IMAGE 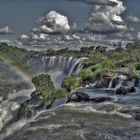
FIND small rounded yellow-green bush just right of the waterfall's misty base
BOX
[62,76,80,92]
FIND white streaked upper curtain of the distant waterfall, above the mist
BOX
[40,56,86,76]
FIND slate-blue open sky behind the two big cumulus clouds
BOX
[0,0,140,38]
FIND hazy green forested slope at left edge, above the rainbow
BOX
[0,43,38,77]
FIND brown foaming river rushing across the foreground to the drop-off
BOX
[0,88,140,140]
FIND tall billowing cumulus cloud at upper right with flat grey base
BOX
[88,0,127,32]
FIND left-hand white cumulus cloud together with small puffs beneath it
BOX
[19,11,74,44]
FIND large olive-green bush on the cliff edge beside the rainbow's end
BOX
[30,74,68,109]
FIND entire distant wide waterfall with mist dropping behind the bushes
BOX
[29,56,86,88]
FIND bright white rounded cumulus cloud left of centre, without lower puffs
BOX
[37,11,71,34]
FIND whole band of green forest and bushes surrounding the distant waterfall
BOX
[0,43,140,101]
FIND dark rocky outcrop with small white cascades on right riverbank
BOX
[90,68,136,95]
